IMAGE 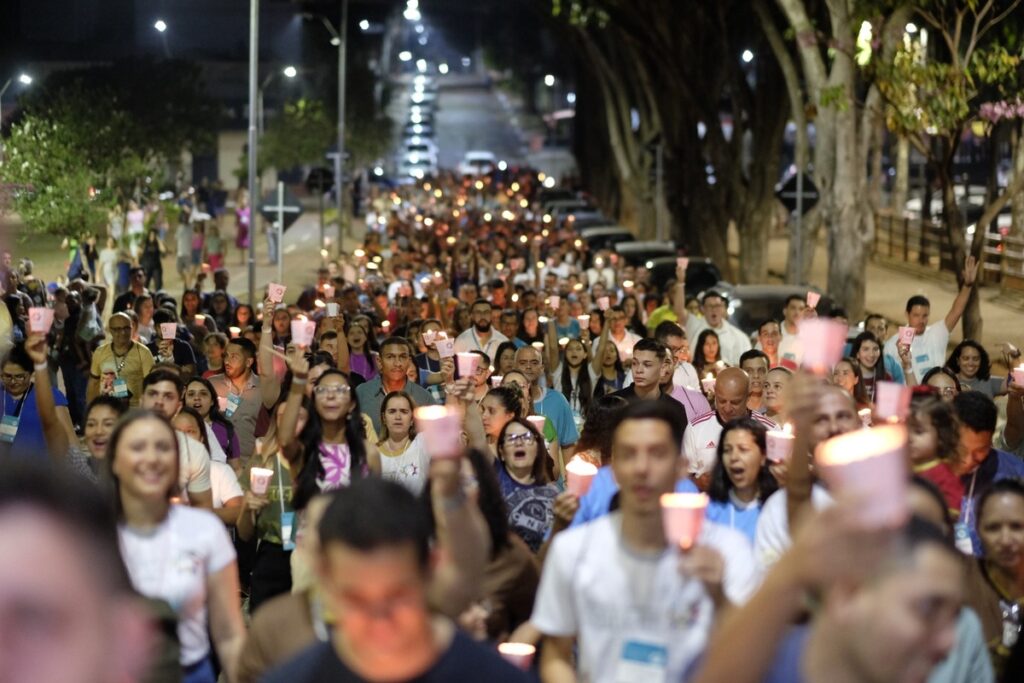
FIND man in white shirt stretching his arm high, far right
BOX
[885,256,978,384]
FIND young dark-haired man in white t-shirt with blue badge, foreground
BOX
[530,401,756,683]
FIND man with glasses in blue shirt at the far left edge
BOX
[0,337,75,459]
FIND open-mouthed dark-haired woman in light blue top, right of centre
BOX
[707,418,778,544]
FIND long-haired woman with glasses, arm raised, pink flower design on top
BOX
[280,348,380,510]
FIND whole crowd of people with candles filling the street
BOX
[0,166,1024,683]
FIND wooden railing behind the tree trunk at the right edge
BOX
[872,212,1024,292]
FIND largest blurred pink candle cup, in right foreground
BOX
[814,425,908,526]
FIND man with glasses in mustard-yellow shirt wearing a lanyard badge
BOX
[85,313,154,408]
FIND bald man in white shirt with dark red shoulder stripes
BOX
[683,368,778,490]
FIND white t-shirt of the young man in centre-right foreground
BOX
[530,513,714,683]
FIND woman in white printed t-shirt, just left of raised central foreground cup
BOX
[377,391,430,496]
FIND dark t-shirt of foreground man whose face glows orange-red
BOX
[262,631,536,683]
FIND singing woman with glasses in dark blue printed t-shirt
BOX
[497,418,567,553]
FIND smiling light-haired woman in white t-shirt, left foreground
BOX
[106,410,245,683]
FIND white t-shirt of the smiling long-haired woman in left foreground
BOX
[118,505,234,667]
